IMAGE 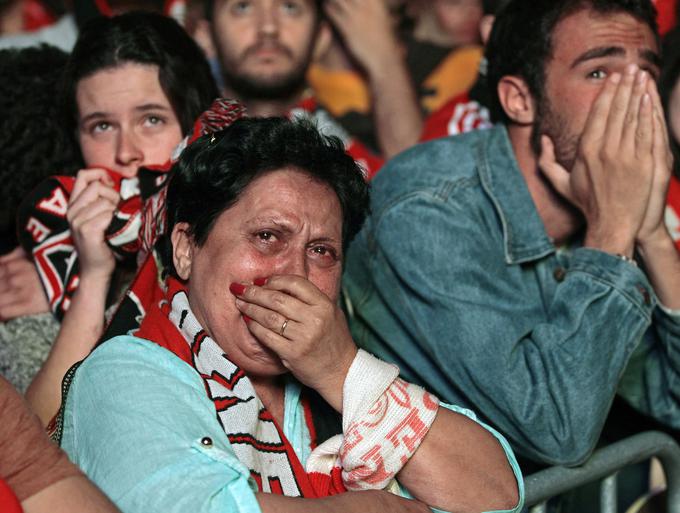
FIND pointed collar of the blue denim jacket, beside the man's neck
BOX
[476,125,555,264]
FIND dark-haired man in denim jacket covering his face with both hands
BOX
[345,0,680,464]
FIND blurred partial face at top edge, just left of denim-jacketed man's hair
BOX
[433,0,484,45]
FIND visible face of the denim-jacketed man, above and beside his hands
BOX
[533,9,659,169]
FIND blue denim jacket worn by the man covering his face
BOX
[344,126,680,464]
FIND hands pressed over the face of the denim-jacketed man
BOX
[539,65,670,256]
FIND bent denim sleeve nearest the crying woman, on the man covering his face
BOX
[345,169,678,465]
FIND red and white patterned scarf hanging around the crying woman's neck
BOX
[137,278,345,498]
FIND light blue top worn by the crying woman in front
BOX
[62,336,524,513]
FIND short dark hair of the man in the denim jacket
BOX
[486,0,658,123]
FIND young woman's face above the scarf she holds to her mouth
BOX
[76,63,182,178]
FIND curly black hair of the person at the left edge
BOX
[0,45,82,249]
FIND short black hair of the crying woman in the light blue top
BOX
[163,118,369,270]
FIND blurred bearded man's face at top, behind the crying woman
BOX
[212,0,318,99]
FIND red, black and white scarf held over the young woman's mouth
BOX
[17,99,246,321]
